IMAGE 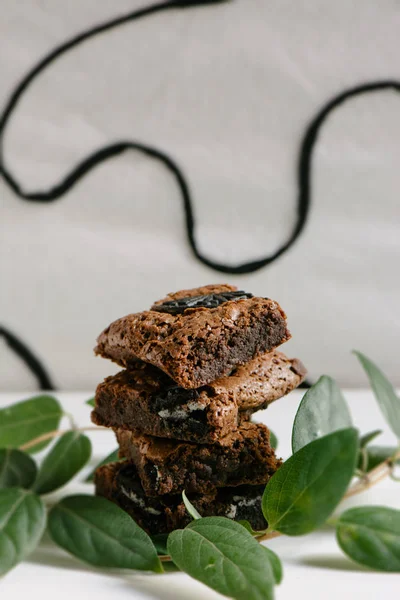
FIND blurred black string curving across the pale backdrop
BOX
[0,0,400,389]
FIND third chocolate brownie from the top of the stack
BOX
[116,423,281,496]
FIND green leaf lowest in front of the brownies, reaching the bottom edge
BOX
[167,517,275,600]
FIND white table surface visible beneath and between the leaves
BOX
[0,390,400,600]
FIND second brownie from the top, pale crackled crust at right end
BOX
[92,352,305,443]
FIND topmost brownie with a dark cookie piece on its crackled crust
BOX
[95,285,290,389]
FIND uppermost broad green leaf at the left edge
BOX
[0,396,63,454]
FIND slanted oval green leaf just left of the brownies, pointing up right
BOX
[34,431,92,494]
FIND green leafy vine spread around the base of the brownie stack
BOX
[0,353,400,600]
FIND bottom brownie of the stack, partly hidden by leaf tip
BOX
[95,463,267,535]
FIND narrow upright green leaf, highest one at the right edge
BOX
[354,350,400,440]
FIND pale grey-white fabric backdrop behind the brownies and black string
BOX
[0,0,400,389]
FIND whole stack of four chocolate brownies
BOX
[92,285,305,534]
